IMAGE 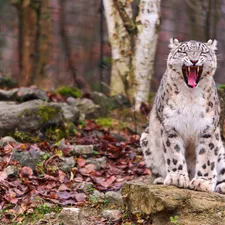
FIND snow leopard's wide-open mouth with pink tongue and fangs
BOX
[182,65,203,88]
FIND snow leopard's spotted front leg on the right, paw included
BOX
[190,132,218,192]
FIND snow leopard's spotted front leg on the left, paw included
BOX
[163,129,189,188]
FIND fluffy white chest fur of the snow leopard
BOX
[163,89,213,138]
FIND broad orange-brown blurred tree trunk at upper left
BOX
[10,0,51,86]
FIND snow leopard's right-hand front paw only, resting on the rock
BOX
[189,177,216,192]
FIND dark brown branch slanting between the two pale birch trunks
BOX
[113,0,137,36]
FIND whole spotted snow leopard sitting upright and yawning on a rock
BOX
[140,39,225,193]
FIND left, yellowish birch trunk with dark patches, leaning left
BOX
[103,0,132,95]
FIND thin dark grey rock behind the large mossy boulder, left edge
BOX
[0,87,48,102]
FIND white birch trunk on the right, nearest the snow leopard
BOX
[132,0,160,111]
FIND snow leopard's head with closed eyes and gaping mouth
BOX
[167,38,217,88]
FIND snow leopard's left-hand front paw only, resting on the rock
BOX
[164,172,189,188]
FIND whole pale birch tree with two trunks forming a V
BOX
[103,0,160,111]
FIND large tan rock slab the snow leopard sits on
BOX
[122,181,225,225]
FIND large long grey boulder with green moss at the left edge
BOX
[0,100,63,136]
